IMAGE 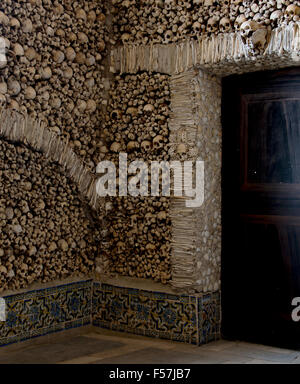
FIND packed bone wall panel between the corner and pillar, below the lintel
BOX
[101,72,171,283]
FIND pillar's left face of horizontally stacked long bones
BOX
[169,71,197,290]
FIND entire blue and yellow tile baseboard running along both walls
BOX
[0,279,220,346]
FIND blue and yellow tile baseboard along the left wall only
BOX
[0,279,93,346]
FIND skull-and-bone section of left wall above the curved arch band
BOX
[0,0,112,167]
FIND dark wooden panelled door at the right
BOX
[222,68,300,348]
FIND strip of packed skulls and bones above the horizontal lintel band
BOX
[112,0,300,44]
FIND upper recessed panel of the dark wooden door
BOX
[245,100,300,184]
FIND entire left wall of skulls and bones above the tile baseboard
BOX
[0,0,114,291]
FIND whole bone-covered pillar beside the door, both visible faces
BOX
[169,69,221,292]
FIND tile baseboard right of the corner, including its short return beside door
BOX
[92,282,221,345]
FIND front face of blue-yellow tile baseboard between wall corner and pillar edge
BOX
[93,284,197,343]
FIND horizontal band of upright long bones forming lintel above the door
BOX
[111,22,300,76]
